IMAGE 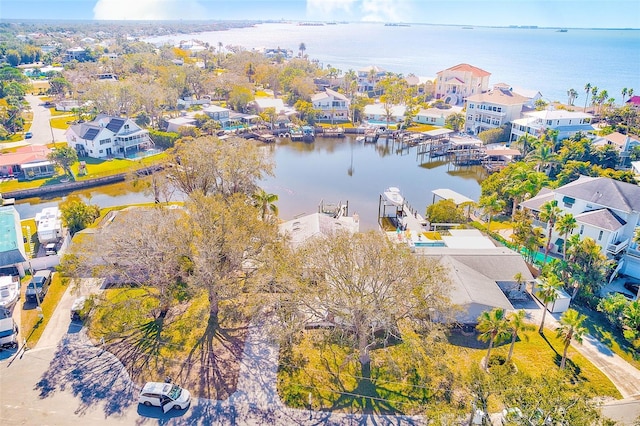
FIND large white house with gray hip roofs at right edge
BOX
[520,176,640,279]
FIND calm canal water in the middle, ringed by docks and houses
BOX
[16,136,485,230]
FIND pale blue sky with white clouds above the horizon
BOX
[0,0,640,28]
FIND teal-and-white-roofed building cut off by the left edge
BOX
[0,206,26,276]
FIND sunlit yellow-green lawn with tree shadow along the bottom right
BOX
[278,322,620,414]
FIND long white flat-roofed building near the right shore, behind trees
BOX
[509,109,594,142]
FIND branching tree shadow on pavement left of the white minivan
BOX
[35,332,135,416]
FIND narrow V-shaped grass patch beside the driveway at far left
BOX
[20,273,68,348]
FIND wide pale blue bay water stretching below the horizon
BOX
[146,23,640,106]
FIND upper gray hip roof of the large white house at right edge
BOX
[556,176,640,213]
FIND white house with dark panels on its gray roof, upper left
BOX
[65,114,154,158]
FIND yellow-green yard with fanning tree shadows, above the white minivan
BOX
[88,288,247,400]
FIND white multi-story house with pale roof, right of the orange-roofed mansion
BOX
[465,88,528,134]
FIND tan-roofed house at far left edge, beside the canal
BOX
[0,145,56,180]
